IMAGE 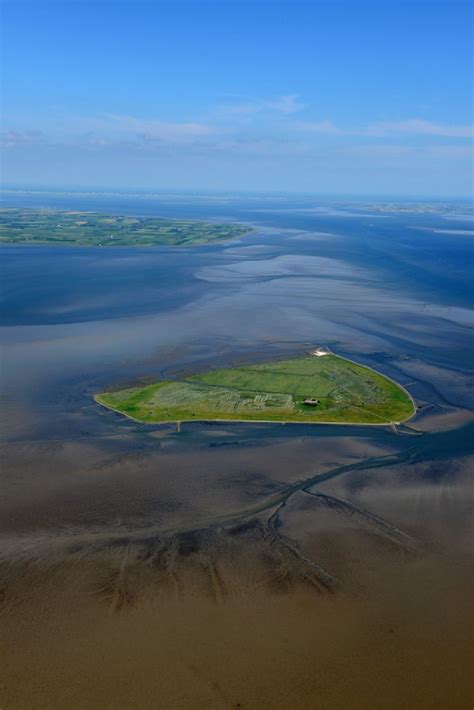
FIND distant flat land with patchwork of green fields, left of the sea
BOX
[0,208,252,247]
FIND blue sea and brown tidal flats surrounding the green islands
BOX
[0,194,474,710]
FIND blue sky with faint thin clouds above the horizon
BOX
[2,0,473,197]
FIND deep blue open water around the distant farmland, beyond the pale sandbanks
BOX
[0,194,474,324]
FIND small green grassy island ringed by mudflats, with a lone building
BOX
[95,348,416,425]
